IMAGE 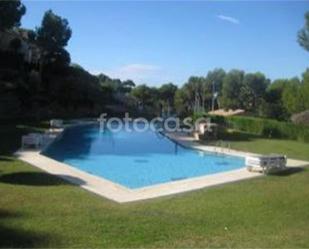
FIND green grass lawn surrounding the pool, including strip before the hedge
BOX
[0,125,309,248]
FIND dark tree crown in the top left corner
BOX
[0,0,26,31]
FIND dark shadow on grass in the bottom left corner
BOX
[0,209,57,248]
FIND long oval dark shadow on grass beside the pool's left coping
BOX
[0,172,85,186]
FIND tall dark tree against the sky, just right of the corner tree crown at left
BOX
[36,10,72,65]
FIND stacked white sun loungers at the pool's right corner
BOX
[246,155,287,174]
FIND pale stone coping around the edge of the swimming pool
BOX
[15,126,309,203]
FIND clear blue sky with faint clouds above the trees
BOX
[22,0,309,86]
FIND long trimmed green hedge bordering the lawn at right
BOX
[225,116,309,142]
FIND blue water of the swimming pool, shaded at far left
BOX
[43,125,244,189]
